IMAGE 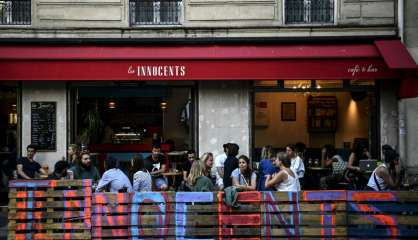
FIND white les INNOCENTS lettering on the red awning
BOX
[128,65,186,77]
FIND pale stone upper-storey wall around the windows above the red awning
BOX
[0,0,397,39]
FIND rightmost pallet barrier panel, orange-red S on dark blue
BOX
[347,192,418,239]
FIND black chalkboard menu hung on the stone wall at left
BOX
[31,102,57,151]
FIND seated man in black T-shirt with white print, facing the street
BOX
[144,145,168,191]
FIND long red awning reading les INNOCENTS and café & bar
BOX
[0,43,412,80]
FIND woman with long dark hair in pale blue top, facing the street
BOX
[231,155,257,191]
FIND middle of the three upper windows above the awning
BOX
[129,0,183,25]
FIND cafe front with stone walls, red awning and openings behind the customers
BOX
[0,0,418,180]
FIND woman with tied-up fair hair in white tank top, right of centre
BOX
[265,152,300,192]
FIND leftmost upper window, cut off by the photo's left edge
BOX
[0,0,31,25]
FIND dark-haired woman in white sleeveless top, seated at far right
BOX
[365,146,401,191]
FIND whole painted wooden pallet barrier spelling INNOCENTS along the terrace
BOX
[9,180,418,239]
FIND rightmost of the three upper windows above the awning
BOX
[285,0,334,24]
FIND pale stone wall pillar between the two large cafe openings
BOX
[198,81,251,156]
